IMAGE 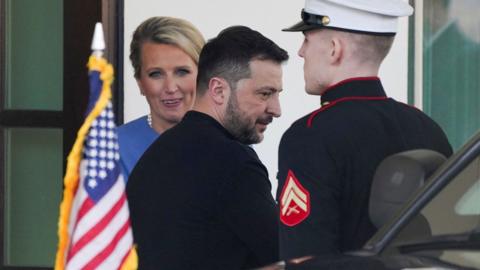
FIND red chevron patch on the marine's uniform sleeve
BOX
[280,170,310,227]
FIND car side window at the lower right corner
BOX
[387,157,480,268]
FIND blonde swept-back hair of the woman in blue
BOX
[130,17,205,79]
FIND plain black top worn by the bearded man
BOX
[127,111,278,270]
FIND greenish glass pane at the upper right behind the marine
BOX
[422,0,480,149]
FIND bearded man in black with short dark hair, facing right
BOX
[127,26,288,270]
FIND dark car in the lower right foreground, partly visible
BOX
[262,133,480,269]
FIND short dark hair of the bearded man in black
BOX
[197,26,288,96]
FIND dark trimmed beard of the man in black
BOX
[224,93,272,144]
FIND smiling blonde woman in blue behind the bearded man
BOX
[118,17,205,177]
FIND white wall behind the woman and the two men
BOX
[124,0,408,192]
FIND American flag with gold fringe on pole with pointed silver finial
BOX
[55,23,138,270]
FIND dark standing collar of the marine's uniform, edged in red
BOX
[321,77,387,106]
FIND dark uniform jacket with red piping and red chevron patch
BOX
[277,77,452,258]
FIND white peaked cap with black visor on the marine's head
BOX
[283,0,413,35]
